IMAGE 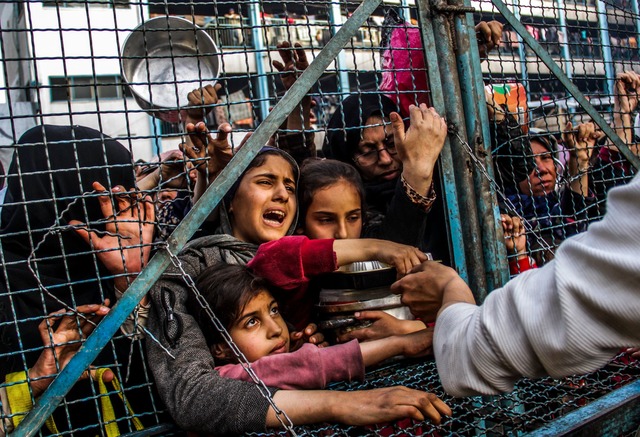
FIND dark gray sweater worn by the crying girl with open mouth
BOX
[146,235,276,435]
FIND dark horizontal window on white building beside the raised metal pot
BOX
[49,75,131,102]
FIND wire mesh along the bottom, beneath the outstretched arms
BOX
[247,356,640,436]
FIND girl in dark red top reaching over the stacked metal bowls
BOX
[248,159,426,341]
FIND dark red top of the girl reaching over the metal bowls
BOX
[247,235,338,330]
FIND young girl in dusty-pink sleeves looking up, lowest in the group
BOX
[189,264,449,420]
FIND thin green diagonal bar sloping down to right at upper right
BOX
[491,0,640,169]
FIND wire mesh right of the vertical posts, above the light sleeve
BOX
[475,1,638,265]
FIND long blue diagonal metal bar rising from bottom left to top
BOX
[12,0,382,436]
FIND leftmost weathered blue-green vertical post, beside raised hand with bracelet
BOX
[416,0,469,281]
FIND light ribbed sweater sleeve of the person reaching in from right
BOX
[434,176,640,396]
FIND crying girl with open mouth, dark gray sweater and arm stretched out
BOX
[147,147,448,435]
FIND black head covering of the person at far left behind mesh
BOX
[0,125,135,374]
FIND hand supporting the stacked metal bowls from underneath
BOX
[337,311,426,343]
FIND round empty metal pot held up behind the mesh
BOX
[121,16,220,123]
